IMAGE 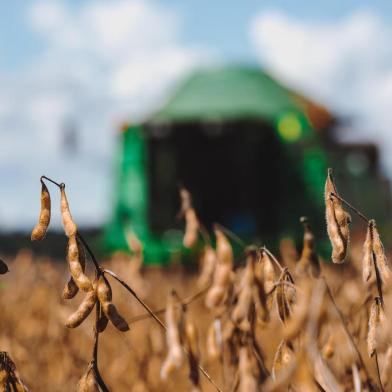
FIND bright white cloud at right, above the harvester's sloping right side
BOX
[250,11,392,175]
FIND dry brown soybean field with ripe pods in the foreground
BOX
[0,171,392,392]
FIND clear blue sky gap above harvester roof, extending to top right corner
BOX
[168,0,392,61]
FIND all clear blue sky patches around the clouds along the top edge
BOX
[0,0,392,69]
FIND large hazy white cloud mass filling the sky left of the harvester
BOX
[0,0,210,228]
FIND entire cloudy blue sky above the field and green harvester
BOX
[0,0,392,229]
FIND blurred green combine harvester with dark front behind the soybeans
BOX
[104,66,390,264]
